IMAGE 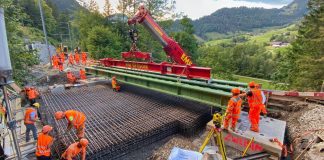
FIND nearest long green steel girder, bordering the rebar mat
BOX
[85,67,246,109]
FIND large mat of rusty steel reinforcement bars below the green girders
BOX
[42,86,210,159]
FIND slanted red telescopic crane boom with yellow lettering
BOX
[128,5,194,66]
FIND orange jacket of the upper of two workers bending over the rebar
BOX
[65,110,87,129]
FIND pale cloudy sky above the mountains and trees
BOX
[96,0,292,19]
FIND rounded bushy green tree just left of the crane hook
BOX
[87,26,122,59]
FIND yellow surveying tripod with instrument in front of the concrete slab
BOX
[199,113,227,160]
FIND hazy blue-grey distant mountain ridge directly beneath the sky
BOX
[193,0,307,38]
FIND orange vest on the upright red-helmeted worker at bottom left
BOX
[36,133,53,157]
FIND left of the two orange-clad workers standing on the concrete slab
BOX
[224,88,242,131]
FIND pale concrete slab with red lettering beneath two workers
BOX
[207,112,286,158]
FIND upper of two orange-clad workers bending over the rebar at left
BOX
[55,110,87,139]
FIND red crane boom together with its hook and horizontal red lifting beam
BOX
[100,5,211,79]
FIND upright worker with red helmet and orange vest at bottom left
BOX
[35,125,54,160]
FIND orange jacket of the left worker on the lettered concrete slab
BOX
[226,96,242,118]
